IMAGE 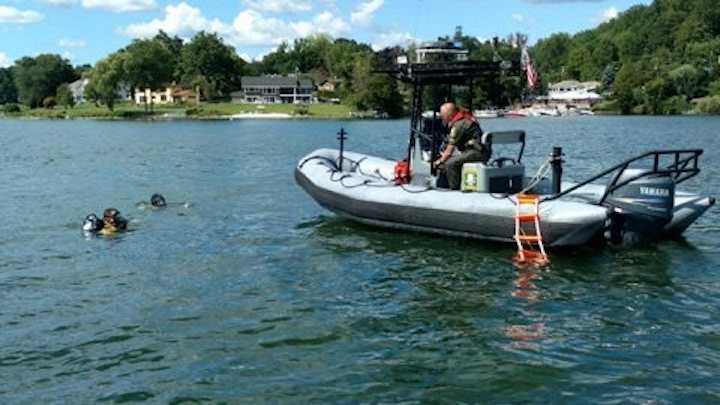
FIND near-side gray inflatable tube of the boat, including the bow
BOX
[295,149,608,247]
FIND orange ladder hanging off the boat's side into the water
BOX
[515,194,550,266]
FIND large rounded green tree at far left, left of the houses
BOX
[14,54,77,108]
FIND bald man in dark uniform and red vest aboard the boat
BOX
[434,103,492,190]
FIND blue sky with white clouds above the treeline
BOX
[0,0,651,67]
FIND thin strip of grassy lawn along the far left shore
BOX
[2,103,353,119]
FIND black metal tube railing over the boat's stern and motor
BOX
[543,149,703,205]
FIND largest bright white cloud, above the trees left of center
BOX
[121,2,350,47]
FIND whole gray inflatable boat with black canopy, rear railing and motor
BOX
[295,51,715,246]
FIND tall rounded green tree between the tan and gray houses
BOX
[179,32,245,99]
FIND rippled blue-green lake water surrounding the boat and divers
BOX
[0,117,720,404]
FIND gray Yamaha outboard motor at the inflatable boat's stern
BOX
[605,169,675,243]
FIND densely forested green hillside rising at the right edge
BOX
[532,0,720,114]
